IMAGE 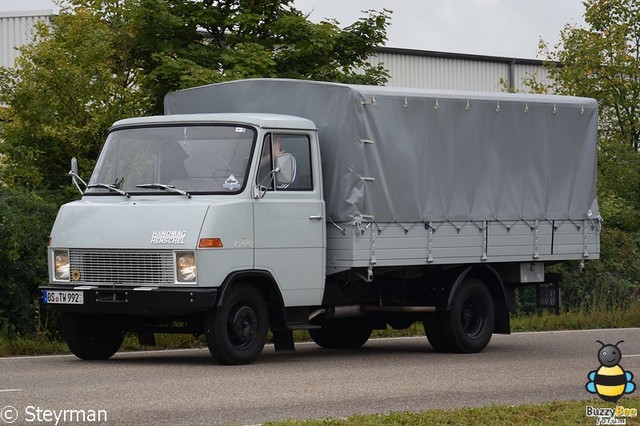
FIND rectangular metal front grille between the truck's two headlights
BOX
[69,249,175,285]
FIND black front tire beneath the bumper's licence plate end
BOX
[61,312,124,360]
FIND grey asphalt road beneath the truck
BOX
[0,328,640,426]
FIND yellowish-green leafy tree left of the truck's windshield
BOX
[0,7,149,188]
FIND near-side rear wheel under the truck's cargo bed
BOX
[442,278,495,353]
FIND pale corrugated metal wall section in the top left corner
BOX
[0,10,53,67]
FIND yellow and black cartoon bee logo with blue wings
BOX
[585,340,636,404]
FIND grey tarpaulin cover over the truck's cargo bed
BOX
[165,79,598,222]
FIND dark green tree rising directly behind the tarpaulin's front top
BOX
[120,0,389,112]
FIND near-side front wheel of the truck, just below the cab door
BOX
[204,283,269,365]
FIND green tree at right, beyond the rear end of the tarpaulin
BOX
[541,0,640,150]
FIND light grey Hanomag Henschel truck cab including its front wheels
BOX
[42,114,325,363]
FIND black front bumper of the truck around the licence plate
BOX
[40,285,218,316]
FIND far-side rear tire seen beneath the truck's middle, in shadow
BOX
[309,318,373,349]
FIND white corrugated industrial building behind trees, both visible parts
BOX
[0,10,549,92]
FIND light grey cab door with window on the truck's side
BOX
[254,133,326,306]
